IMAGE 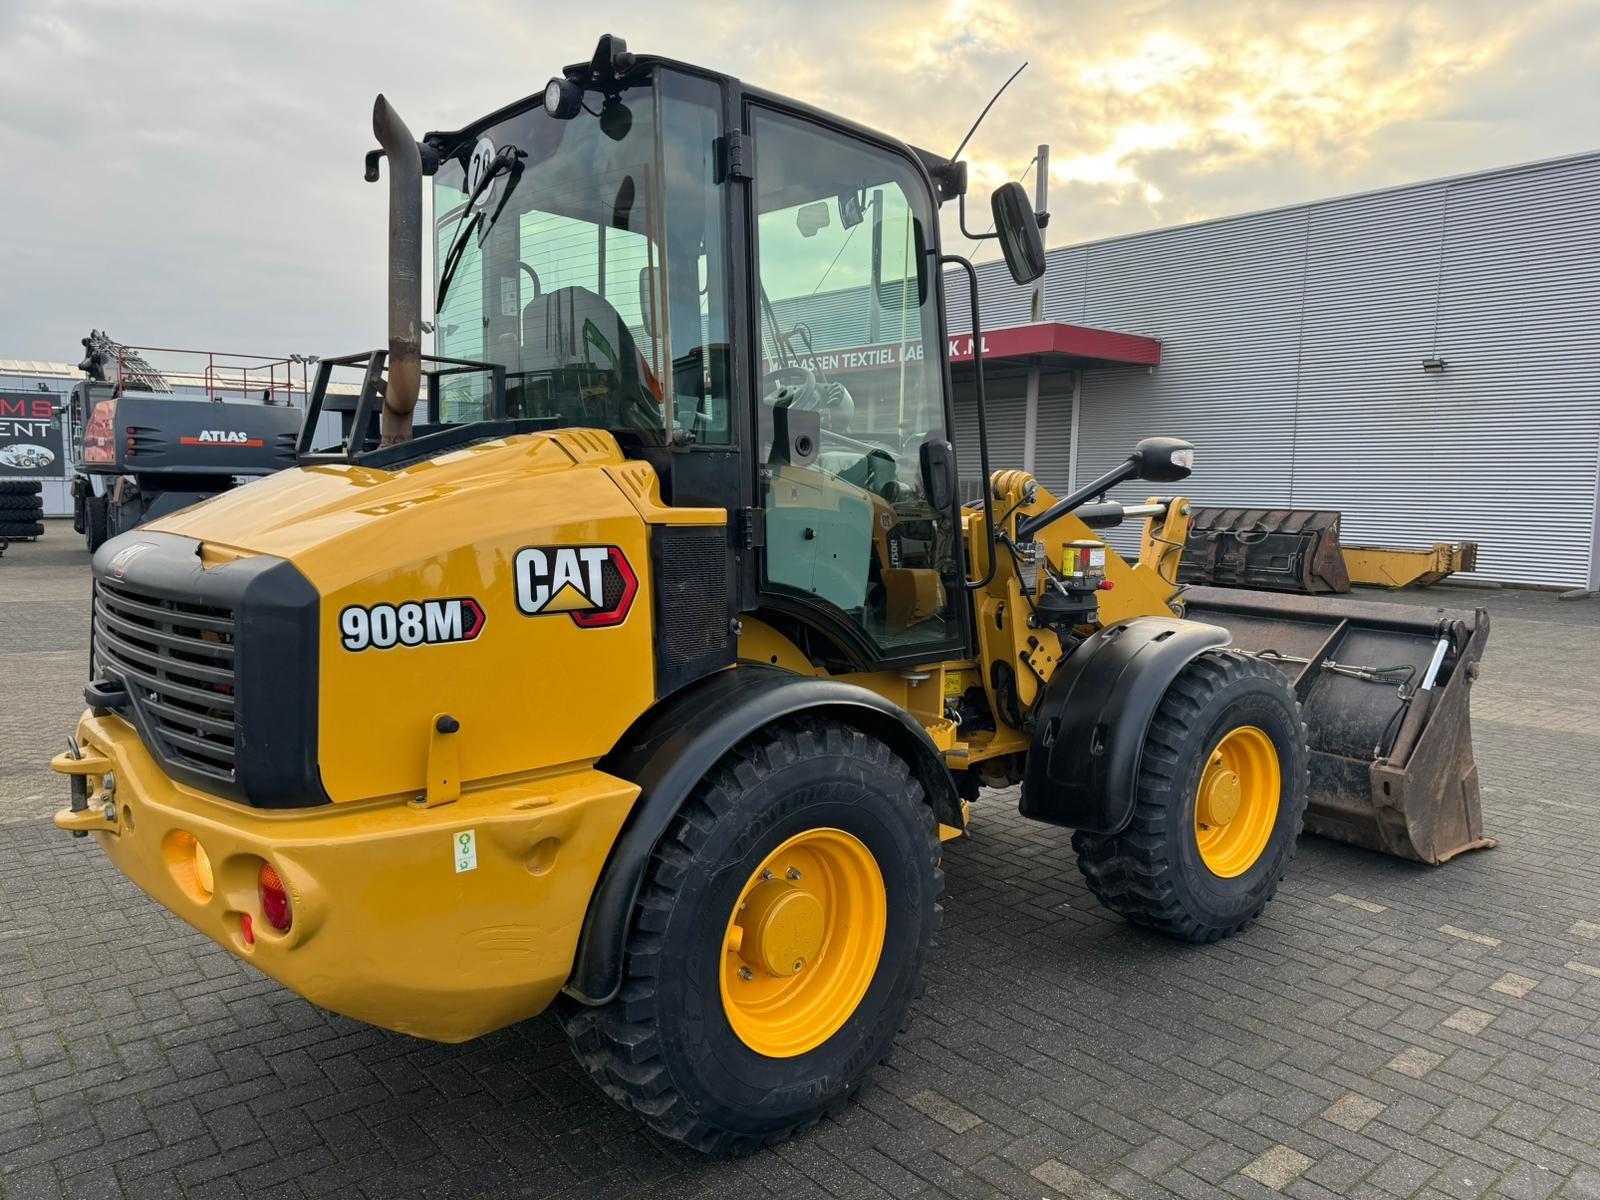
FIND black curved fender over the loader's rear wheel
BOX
[566,664,965,1005]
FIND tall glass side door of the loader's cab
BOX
[749,106,966,666]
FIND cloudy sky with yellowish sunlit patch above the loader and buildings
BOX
[0,0,1600,362]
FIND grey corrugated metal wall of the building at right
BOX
[946,154,1600,586]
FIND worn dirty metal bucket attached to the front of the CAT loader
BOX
[1182,587,1494,864]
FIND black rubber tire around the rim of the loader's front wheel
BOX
[1072,650,1310,942]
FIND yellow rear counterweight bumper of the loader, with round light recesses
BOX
[51,712,638,1042]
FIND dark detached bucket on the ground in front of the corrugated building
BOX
[1178,507,1350,594]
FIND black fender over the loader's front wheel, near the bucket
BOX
[1019,616,1230,834]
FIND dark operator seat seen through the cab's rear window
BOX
[518,286,661,429]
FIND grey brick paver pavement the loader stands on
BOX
[0,522,1600,1200]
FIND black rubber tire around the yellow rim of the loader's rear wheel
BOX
[558,718,942,1154]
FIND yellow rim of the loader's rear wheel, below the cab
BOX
[722,829,888,1058]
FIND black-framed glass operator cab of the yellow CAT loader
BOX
[344,37,1037,669]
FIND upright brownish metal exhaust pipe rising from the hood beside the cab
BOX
[368,94,422,446]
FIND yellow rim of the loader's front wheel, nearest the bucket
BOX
[1195,725,1283,878]
